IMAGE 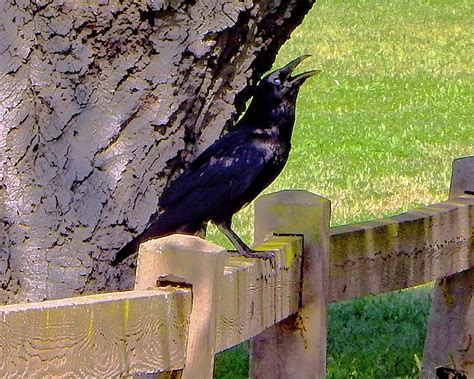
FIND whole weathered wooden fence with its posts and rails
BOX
[0,157,474,378]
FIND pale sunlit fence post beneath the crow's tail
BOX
[135,235,226,379]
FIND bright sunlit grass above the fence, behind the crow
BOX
[211,0,474,248]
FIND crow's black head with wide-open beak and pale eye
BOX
[243,55,320,127]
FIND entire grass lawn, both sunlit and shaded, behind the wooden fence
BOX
[210,0,474,378]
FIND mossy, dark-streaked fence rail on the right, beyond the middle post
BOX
[329,195,474,301]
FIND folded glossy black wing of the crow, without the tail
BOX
[160,130,272,207]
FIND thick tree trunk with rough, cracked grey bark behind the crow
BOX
[0,0,314,303]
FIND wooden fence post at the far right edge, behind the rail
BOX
[422,156,474,378]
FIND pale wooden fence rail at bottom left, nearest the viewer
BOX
[0,288,191,377]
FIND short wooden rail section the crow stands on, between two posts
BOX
[216,236,302,351]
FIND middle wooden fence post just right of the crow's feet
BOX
[250,191,330,379]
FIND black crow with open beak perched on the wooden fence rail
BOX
[113,55,320,265]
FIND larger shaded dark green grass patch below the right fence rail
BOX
[327,286,432,379]
